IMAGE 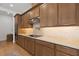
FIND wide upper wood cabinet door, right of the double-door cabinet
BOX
[59,3,75,25]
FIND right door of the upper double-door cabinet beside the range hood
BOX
[47,3,57,27]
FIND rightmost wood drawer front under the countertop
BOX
[56,45,78,55]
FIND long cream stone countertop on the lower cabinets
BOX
[19,34,79,49]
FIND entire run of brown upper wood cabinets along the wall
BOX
[15,3,79,28]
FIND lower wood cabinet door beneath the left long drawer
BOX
[35,43,52,56]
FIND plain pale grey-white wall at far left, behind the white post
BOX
[0,15,13,41]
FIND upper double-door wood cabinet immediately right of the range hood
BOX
[40,3,57,27]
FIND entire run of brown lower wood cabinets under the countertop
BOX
[16,35,79,56]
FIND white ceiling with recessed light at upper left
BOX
[0,3,32,14]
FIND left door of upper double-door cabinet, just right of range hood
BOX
[40,4,48,27]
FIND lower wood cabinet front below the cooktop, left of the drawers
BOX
[25,37,35,55]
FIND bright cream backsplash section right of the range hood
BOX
[41,26,79,39]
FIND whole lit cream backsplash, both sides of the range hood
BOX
[19,26,79,39]
